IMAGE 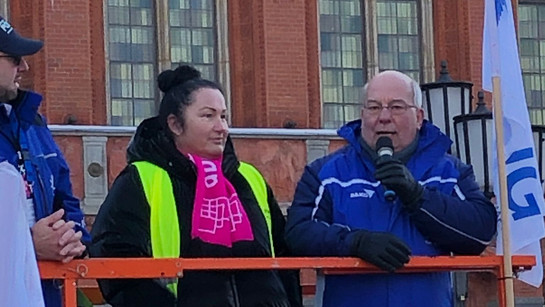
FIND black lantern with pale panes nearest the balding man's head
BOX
[420,60,473,155]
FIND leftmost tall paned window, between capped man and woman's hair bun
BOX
[108,0,157,126]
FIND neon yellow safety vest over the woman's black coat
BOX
[132,161,275,296]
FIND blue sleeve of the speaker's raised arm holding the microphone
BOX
[411,160,497,255]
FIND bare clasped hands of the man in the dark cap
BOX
[32,209,85,263]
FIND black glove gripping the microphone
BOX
[375,157,424,210]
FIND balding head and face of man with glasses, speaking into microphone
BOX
[361,72,424,152]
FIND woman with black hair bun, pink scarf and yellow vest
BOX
[90,66,302,307]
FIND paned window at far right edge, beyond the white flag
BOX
[518,1,545,125]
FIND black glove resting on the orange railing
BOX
[351,230,411,272]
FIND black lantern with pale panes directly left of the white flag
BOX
[454,91,495,198]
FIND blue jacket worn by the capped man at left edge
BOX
[0,91,90,307]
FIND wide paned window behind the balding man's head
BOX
[319,0,434,129]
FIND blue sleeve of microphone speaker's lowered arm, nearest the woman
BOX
[286,158,352,256]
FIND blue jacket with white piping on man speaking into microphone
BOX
[286,120,497,307]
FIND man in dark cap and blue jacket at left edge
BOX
[0,16,90,307]
